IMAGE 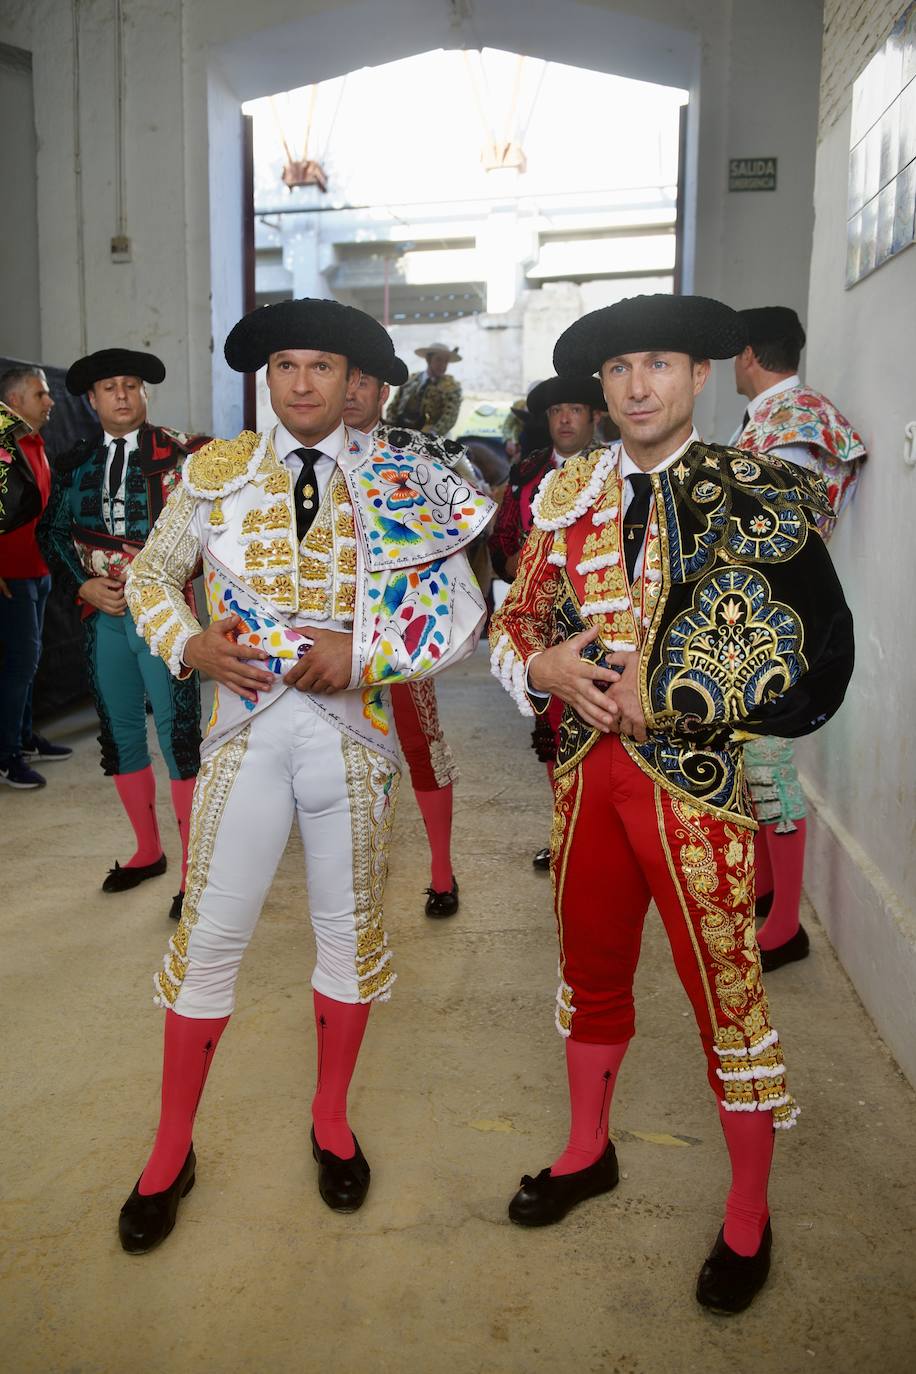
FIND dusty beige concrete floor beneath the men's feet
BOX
[0,651,916,1374]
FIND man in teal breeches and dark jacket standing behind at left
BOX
[40,348,209,921]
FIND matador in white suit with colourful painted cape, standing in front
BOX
[119,300,492,1253]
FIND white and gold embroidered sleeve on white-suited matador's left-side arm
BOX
[125,484,202,679]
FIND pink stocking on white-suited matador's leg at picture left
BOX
[140,1010,229,1197]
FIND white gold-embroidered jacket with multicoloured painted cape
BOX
[126,431,492,761]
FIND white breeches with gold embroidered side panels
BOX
[155,690,400,1018]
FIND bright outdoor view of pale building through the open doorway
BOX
[246,49,687,397]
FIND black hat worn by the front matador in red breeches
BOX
[553,295,747,376]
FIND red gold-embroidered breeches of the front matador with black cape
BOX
[551,735,797,1125]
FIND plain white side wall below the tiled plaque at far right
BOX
[799,85,916,1083]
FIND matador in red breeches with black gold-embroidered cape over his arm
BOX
[490,295,853,1312]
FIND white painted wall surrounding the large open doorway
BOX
[0,0,820,436]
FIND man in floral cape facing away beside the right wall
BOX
[733,305,867,971]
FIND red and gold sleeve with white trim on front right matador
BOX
[490,529,560,716]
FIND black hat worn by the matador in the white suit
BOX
[224,297,394,376]
